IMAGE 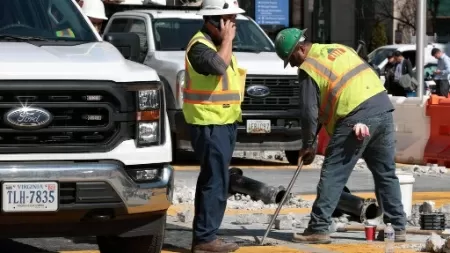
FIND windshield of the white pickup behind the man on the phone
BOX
[153,18,275,53]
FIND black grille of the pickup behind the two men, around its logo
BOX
[242,76,299,110]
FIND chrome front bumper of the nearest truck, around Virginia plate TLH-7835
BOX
[0,161,174,214]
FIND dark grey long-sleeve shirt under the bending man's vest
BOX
[298,70,394,148]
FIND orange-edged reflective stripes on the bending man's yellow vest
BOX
[303,58,370,124]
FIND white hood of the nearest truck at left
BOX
[0,42,159,82]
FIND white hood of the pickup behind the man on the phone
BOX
[155,51,297,75]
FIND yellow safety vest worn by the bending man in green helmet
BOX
[300,44,385,135]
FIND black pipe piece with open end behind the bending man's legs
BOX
[332,187,382,223]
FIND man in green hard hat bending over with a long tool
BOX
[275,28,406,243]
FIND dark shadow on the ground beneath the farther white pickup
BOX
[172,151,289,166]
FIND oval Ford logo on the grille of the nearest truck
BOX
[4,107,53,130]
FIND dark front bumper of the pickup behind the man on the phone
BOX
[172,110,302,151]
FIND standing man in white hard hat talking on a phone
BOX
[183,0,245,253]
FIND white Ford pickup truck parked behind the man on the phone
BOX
[104,5,302,164]
